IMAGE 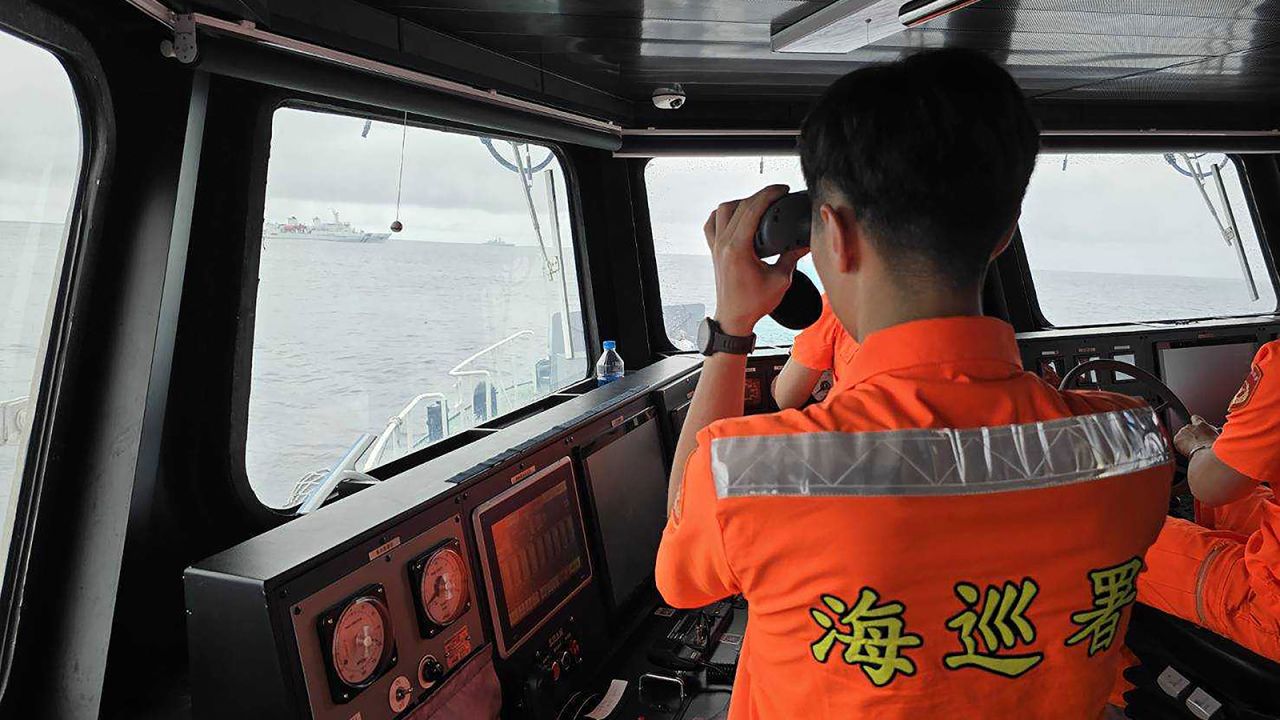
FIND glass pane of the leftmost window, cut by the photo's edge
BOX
[0,32,84,577]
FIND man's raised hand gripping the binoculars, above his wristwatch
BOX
[703,184,809,336]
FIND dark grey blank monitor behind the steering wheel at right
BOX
[1156,340,1257,429]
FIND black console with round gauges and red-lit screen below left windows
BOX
[184,357,700,720]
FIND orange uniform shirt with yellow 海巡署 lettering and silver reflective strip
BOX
[657,318,1172,720]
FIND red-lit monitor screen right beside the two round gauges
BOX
[475,457,591,657]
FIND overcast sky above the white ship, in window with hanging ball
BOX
[266,109,570,245]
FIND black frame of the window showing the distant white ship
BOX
[229,98,598,512]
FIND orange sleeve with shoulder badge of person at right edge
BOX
[1213,342,1280,483]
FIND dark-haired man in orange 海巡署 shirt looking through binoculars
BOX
[657,50,1172,720]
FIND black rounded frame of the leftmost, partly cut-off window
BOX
[0,0,115,706]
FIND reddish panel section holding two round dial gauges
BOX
[289,514,484,720]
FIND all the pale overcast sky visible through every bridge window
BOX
[0,21,1262,278]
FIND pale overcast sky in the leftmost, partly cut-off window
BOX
[0,32,81,223]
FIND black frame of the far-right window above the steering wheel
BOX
[1002,153,1280,331]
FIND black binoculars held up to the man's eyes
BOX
[754,190,822,331]
